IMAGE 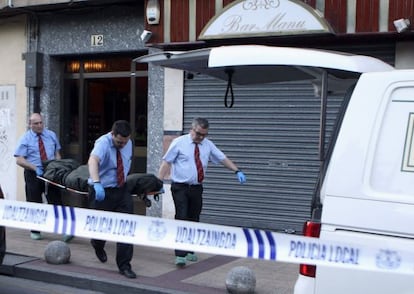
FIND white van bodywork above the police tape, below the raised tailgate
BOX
[321,71,414,234]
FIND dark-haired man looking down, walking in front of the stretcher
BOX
[88,120,136,279]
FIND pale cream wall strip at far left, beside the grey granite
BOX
[0,15,27,199]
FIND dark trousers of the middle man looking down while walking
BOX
[89,185,134,271]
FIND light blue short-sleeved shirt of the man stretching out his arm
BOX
[163,134,226,185]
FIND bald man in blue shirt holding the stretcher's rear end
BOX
[14,113,63,241]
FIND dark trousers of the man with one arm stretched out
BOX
[171,183,203,257]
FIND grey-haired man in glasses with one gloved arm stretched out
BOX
[158,118,246,266]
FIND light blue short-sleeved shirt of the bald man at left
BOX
[14,129,62,167]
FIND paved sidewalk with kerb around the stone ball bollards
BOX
[0,228,298,294]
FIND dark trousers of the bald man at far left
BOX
[24,169,63,233]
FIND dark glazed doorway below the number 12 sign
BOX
[61,55,148,173]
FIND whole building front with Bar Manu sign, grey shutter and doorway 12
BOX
[0,0,414,232]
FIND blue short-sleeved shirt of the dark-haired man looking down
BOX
[89,133,132,188]
